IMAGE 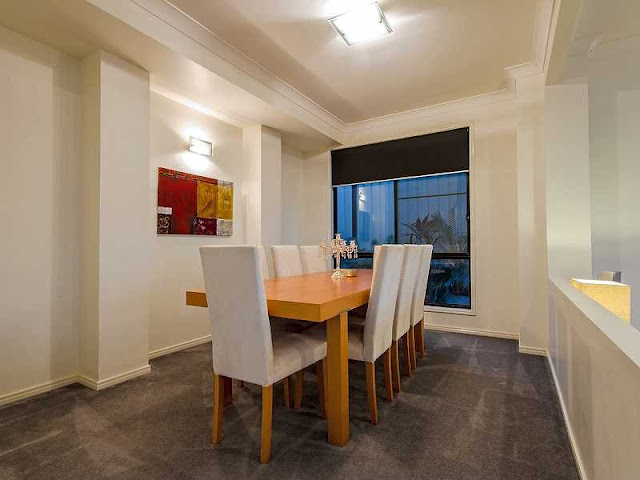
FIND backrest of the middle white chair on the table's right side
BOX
[393,245,424,340]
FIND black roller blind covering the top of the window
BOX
[331,127,469,185]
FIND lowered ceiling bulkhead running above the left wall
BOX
[0,0,336,152]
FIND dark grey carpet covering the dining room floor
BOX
[0,333,578,480]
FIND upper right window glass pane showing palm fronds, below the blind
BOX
[398,173,469,254]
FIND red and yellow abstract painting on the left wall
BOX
[157,168,233,237]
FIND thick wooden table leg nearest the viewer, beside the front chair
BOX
[326,312,349,446]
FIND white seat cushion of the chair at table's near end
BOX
[271,331,327,383]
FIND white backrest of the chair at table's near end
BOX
[200,246,273,386]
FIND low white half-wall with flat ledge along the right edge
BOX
[549,278,640,480]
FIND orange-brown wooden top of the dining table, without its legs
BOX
[187,270,373,322]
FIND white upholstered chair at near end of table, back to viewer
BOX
[200,246,327,463]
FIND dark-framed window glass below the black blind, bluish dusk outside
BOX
[334,171,471,309]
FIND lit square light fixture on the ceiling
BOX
[329,2,392,47]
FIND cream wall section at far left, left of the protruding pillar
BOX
[0,28,80,403]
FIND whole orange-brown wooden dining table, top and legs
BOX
[186,270,372,446]
